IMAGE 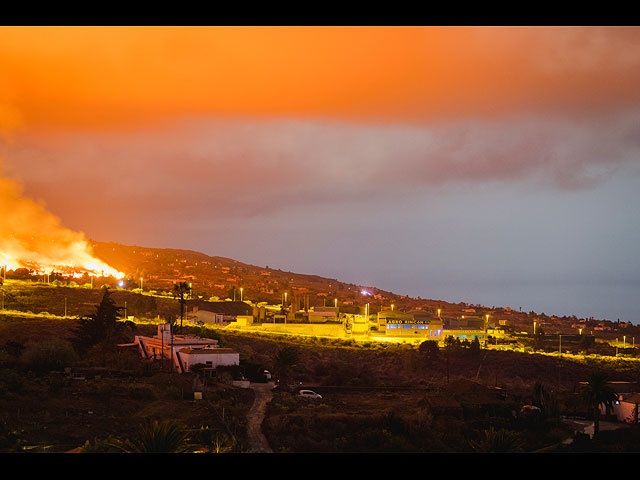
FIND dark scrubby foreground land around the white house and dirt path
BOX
[0,306,640,453]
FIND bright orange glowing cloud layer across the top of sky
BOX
[0,27,640,126]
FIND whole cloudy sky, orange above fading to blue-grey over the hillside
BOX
[0,27,640,323]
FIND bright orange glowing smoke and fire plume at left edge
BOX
[0,166,124,278]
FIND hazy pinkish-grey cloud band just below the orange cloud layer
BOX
[6,111,640,229]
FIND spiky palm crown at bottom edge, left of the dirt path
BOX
[111,420,193,453]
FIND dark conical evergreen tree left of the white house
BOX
[73,288,135,351]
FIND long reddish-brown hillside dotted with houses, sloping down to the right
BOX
[85,242,616,333]
